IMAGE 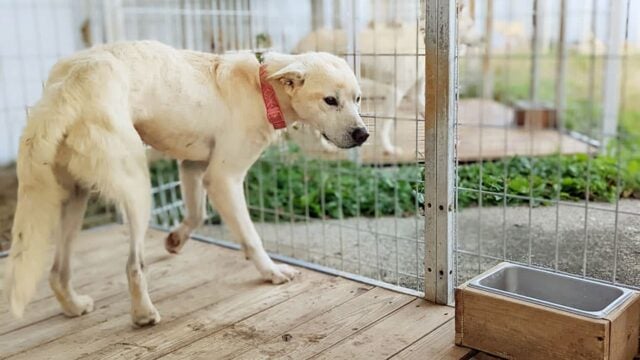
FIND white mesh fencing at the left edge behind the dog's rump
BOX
[0,0,117,233]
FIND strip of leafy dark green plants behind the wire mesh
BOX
[152,144,640,221]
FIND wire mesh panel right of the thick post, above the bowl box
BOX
[455,0,640,287]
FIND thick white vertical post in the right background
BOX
[594,0,626,146]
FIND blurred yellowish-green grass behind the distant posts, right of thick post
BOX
[460,52,640,138]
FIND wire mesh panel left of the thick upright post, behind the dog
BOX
[108,0,432,292]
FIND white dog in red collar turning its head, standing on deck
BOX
[5,41,369,326]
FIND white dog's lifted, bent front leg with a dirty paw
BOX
[164,160,207,254]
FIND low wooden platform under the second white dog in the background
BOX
[300,99,593,164]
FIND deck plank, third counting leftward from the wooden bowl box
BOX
[175,285,413,360]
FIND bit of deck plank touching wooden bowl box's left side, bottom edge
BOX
[392,320,472,360]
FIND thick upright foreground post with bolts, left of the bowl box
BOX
[424,0,457,304]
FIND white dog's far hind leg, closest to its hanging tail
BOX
[49,185,93,316]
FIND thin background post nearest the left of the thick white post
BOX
[555,0,567,130]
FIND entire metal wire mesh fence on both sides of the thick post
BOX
[0,0,640,294]
